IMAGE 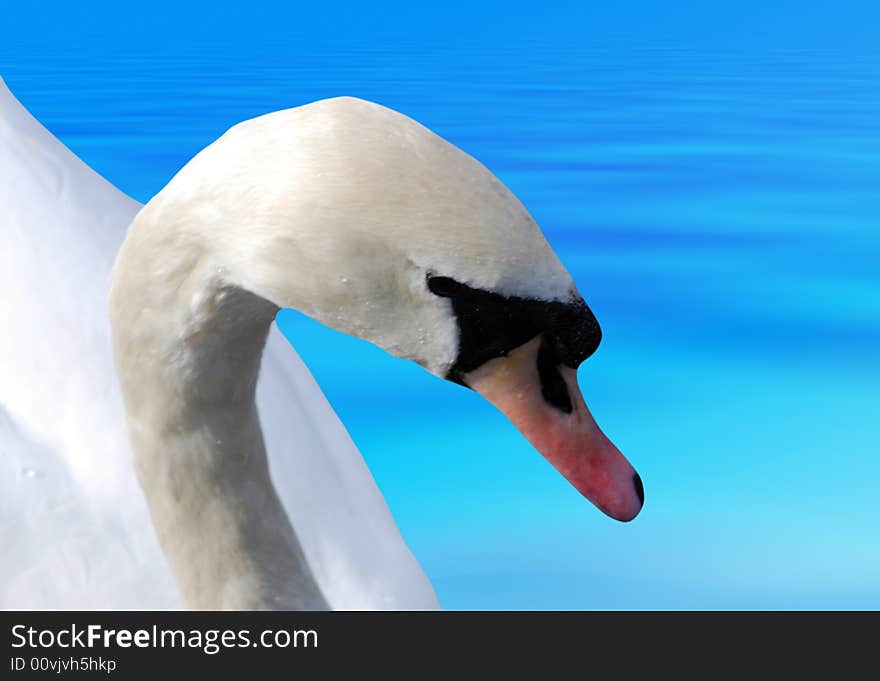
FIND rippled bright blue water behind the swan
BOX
[0,0,880,608]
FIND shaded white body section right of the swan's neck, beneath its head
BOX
[257,324,439,610]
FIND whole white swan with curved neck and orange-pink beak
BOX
[0,81,644,609]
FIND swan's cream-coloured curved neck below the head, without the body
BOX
[111,245,327,610]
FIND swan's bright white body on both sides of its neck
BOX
[0,80,437,609]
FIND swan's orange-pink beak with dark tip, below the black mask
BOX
[463,336,645,522]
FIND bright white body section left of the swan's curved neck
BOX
[0,80,179,609]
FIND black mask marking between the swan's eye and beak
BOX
[427,275,602,386]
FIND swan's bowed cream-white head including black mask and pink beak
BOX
[139,97,643,521]
